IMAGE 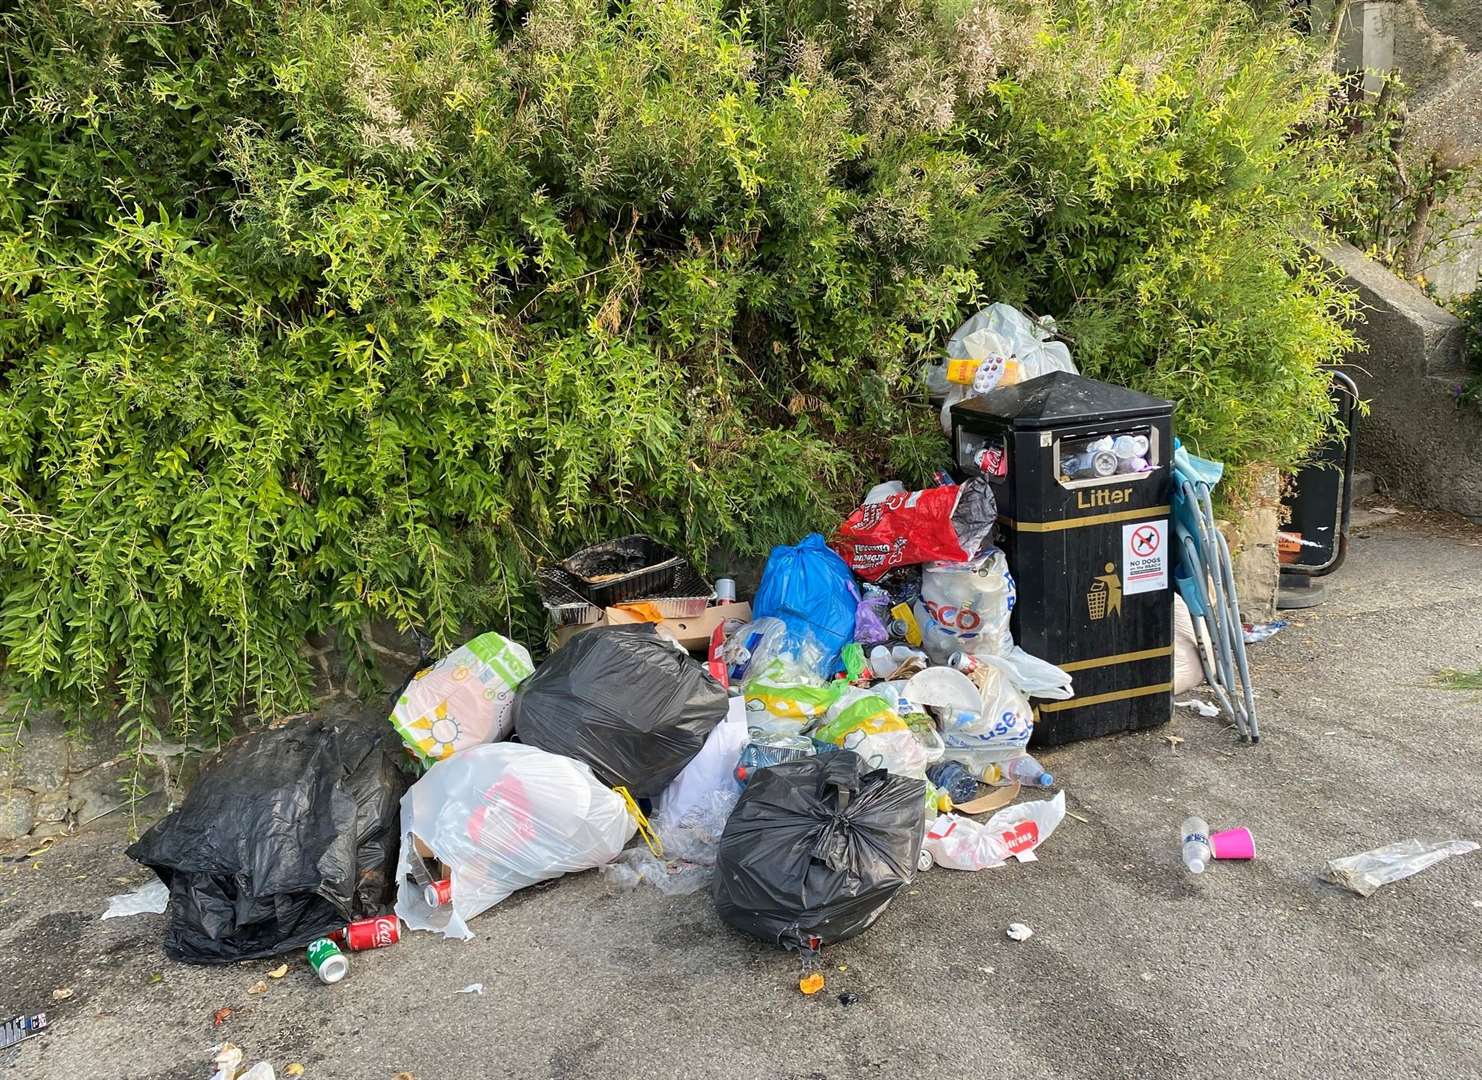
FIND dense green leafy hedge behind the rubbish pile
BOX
[0,0,1350,738]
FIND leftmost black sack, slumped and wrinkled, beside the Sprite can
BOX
[127,717,408,963]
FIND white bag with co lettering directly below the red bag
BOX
[916,548,1018,664]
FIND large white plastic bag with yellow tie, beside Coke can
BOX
[396,742,637,938]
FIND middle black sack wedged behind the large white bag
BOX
[514,624,726,799]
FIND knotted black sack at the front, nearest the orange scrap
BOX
[714,750,926,948]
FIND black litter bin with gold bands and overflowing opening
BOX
[951,372,1174,745]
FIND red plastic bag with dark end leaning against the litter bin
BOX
[831,477,999,581]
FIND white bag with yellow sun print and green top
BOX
[391,633,535,766]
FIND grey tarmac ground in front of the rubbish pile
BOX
[0,513,1482,1080]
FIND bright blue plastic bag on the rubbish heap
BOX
[751,532,860,679]
